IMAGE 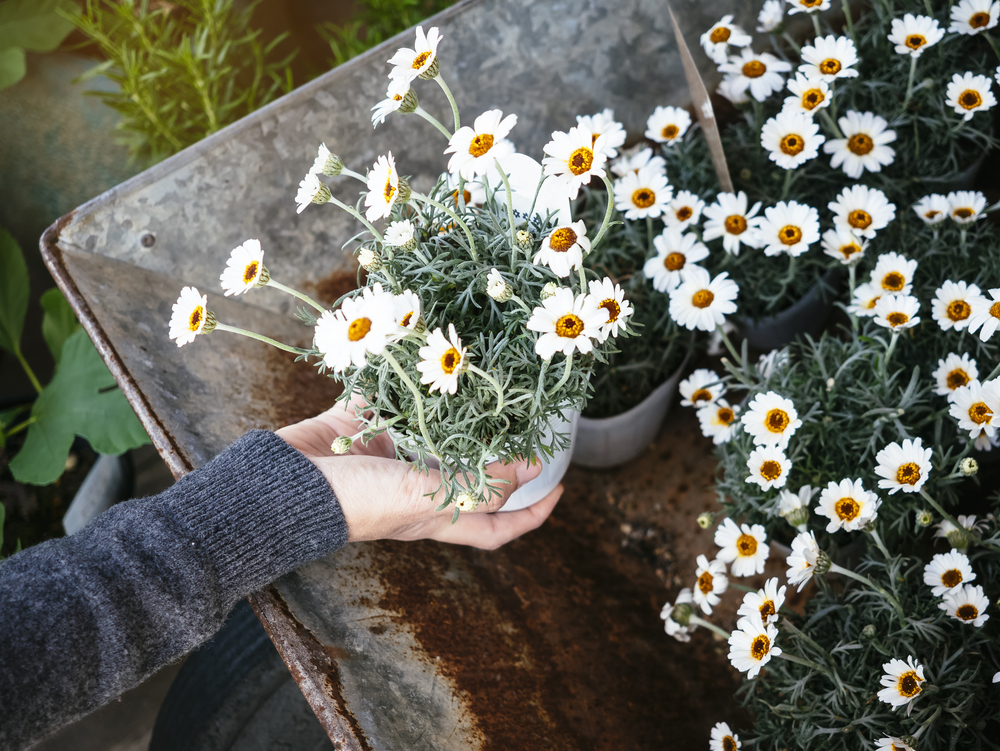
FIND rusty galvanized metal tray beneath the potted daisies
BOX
[42,0,753,751]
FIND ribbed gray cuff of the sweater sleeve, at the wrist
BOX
[164,430,347,599]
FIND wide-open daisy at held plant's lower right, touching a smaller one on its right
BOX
[527,287,608,360]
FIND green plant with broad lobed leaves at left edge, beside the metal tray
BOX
[0,229,149,485]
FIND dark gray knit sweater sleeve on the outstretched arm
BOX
[0,430,347,751]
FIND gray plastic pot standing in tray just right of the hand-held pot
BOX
[573,353,691,469]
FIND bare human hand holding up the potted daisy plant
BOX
[277,402,563,550]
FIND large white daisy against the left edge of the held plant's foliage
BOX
[314,296,397,373]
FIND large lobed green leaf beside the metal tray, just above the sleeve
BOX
[10,329,149,485]
